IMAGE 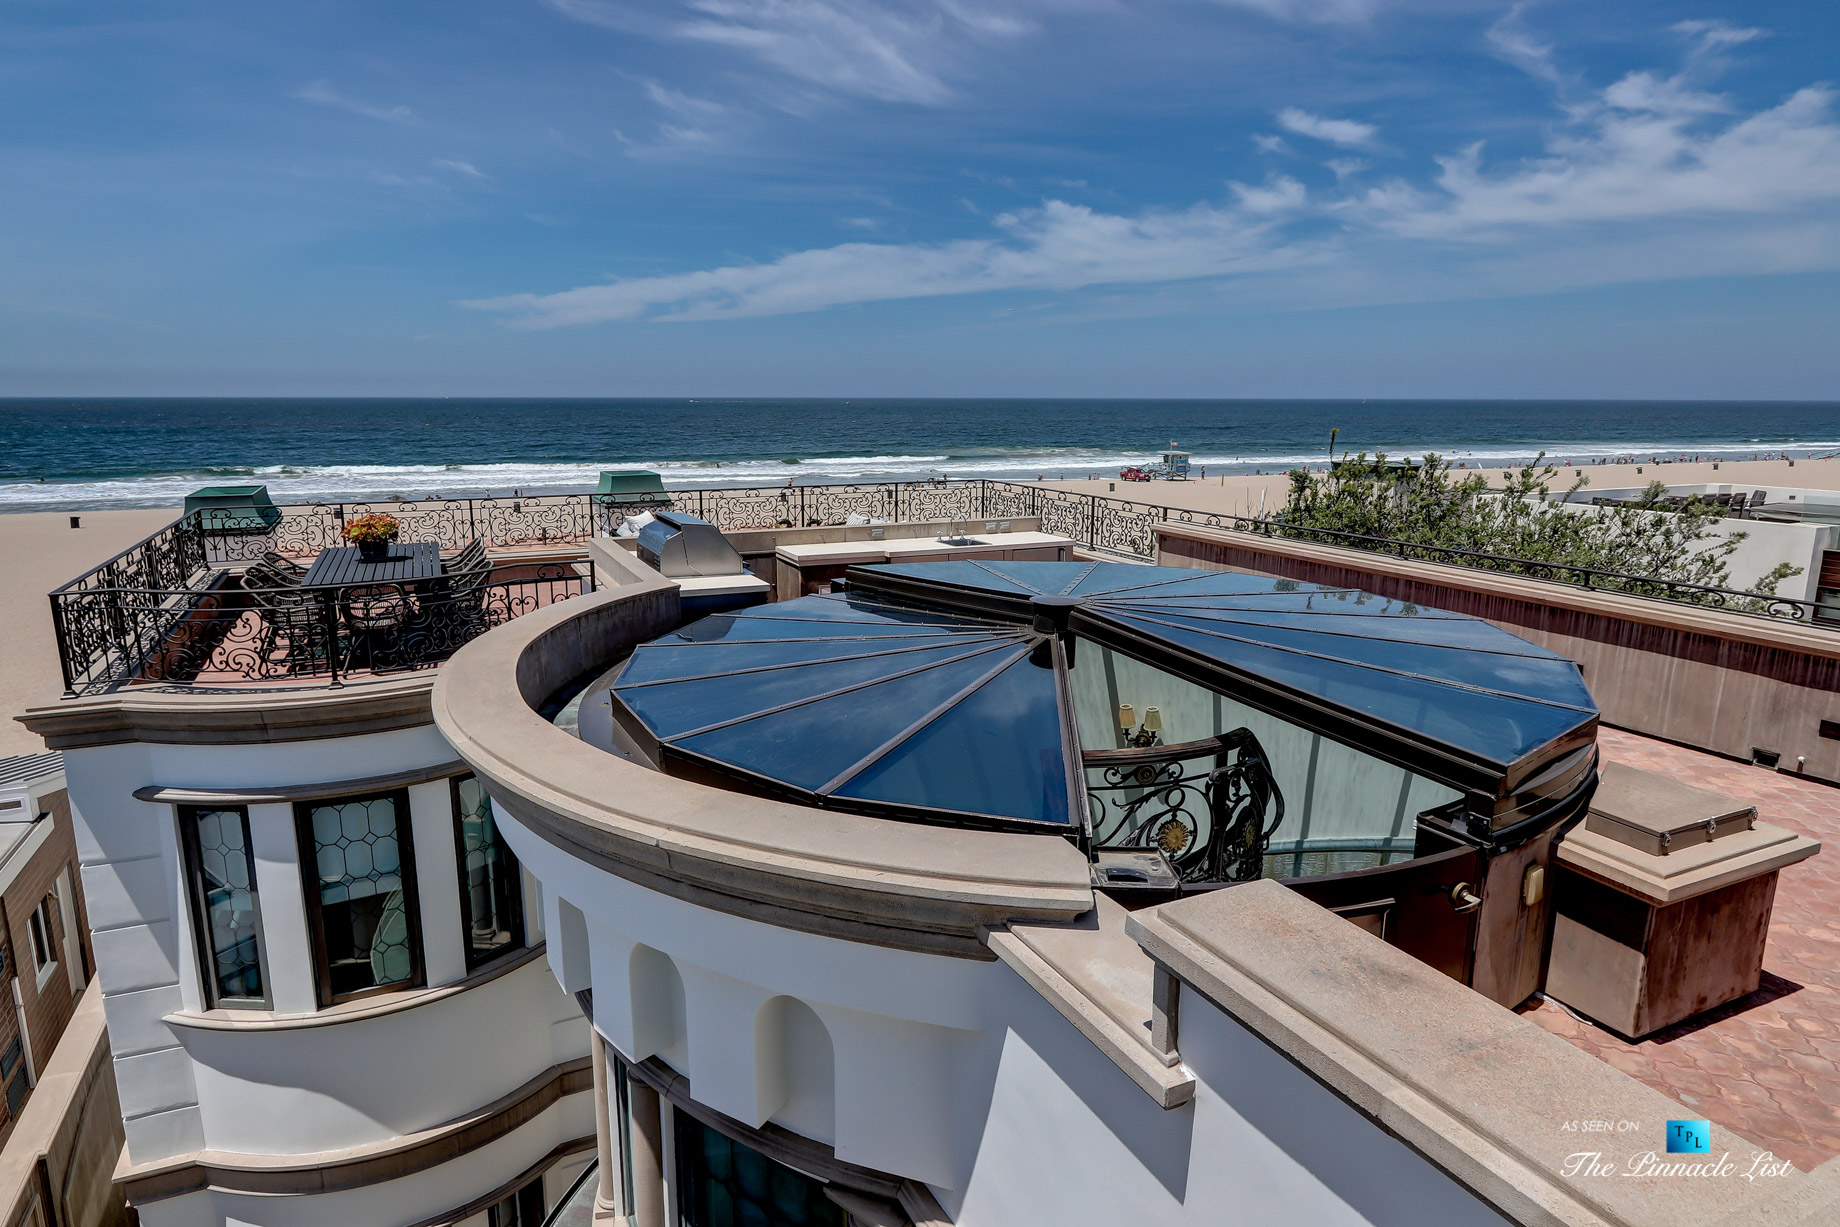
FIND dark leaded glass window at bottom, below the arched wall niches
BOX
[672,1111,845,1227]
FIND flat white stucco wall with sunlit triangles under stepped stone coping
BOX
[937,975,1507,1227]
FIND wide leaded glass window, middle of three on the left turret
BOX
[294,789,421,1004]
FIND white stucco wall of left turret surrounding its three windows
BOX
[66,725,591,1223]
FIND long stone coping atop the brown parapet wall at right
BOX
[1154,521,1840,660]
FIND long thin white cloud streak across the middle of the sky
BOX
[460,188,1319,327]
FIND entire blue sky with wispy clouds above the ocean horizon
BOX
[0,0,1840,399]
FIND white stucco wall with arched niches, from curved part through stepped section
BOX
[504,798,1503,1227]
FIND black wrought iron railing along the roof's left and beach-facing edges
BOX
[52,478,1840,694]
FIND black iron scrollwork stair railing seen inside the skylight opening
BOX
[1084,728,1284,883]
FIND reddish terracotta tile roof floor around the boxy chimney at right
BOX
[1525,728,1840,1172]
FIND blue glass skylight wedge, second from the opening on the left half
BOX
[677,651,1012,791]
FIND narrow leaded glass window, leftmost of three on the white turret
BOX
[178,808,269,1010]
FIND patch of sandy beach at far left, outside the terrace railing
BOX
[0,508,178,756]
